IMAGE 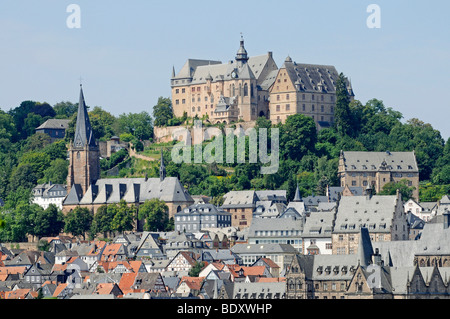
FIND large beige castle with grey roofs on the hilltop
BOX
[171,38,354,130]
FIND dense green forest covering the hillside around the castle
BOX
[0,74,450,240]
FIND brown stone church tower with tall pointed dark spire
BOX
[67,85,100,195]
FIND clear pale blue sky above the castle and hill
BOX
[0,0,450,139]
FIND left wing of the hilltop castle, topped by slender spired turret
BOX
[171,39,278,124]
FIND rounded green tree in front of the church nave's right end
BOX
[138,198,169,231]
